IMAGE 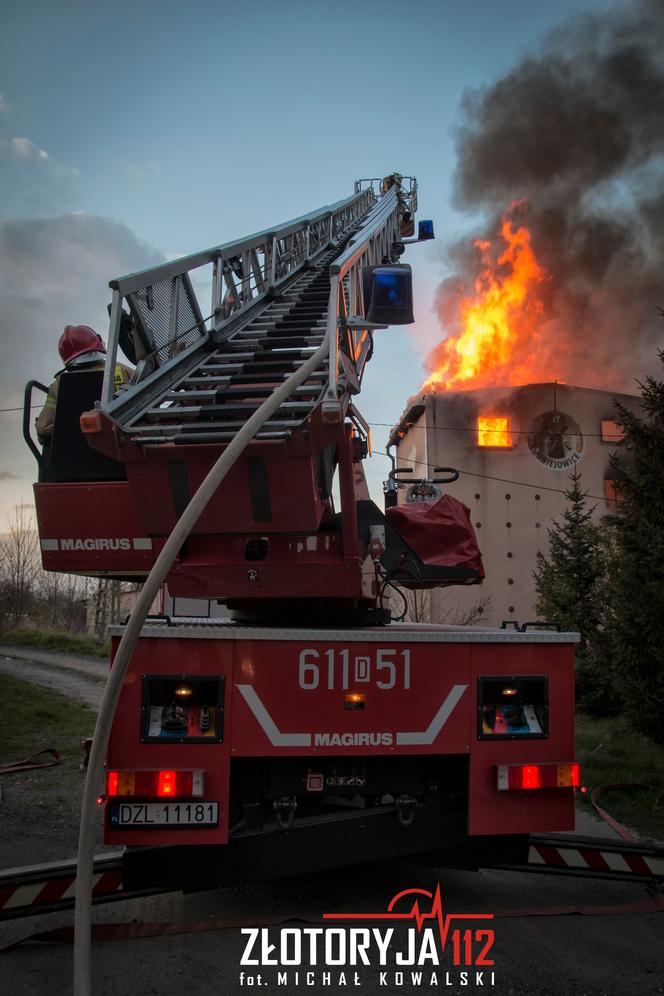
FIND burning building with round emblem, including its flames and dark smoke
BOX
[391,0,664,623]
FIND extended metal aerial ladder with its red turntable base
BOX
[26,178,478,622]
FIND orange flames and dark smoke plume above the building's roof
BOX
[424,0,664,392]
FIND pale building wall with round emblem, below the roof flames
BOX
[392,384,640,626]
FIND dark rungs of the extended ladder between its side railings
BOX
[125,247,343,446]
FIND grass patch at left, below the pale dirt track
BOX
[0,675,95,767]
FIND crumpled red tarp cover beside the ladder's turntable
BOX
[385,495,484,578]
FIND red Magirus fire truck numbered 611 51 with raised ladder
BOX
[24,177,579,885]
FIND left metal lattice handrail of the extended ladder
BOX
[102,188,375,405]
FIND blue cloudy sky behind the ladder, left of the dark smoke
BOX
[0,0,625,525]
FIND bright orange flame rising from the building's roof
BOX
[423,209,550,390]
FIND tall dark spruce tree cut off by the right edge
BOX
[609,352,664,742]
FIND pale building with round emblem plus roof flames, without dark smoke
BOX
[400,202,640,625]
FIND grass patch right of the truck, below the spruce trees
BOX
[576,713,664,840]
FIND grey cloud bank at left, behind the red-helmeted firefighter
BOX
[0,213,164,504]
